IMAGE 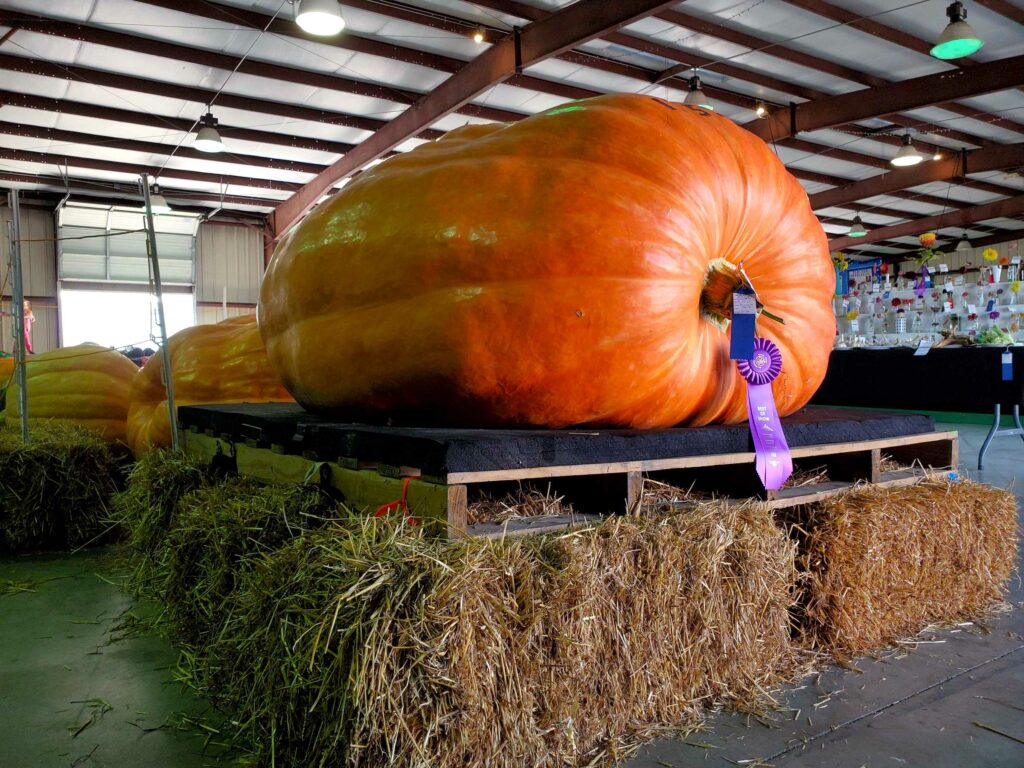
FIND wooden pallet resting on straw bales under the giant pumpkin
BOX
[181,430,959,538]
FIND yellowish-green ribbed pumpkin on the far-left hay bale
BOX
[4,344,138,443]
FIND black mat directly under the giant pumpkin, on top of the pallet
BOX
[178,403,935,475]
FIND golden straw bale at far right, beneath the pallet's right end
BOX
[787,480,1018,655]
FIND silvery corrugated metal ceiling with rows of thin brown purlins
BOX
[0,0,1024,259]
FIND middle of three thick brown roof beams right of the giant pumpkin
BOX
[810,142,1024,209]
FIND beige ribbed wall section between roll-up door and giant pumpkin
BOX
[196,223,263,303]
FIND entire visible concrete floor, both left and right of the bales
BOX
[0,425,1024,768]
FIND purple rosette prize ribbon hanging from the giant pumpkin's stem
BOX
[736,338,793,490]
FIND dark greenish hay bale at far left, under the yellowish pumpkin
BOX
[0,424,123,552]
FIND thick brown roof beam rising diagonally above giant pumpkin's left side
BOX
[272,0,684,237]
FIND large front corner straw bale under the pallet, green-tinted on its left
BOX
[128,473,796,768]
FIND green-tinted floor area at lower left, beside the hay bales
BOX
[0,551,234,768]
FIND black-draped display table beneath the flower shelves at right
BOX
[811,347,1024,469]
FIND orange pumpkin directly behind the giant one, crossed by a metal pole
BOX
[128,315,292,458]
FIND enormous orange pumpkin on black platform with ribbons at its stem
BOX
[259,95,835,427]
